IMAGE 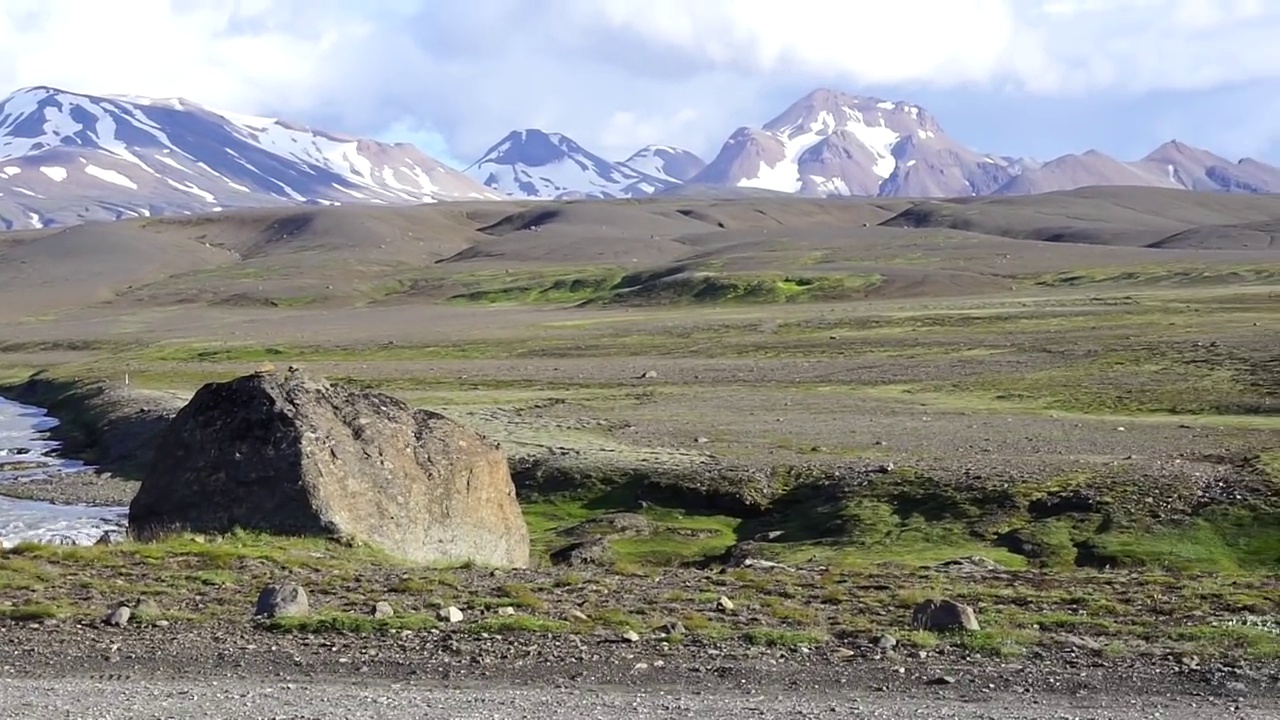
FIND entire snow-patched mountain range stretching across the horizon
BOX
[0,87,1280,229]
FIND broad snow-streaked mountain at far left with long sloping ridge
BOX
[0,87,499,228]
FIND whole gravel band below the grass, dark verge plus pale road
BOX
[0,625,1280,720]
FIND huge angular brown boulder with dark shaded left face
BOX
[129,369,529,568]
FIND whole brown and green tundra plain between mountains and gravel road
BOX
[0,188,1280,707]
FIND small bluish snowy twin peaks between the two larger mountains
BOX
[463,128,701,199]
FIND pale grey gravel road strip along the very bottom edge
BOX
[0,679,1280,720]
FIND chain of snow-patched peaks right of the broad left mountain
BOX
[467,88,1280,199]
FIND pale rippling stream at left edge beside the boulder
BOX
[0,397,128,547]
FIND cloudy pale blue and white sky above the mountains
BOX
[0,0,1280,168]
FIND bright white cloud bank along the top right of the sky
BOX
[566,0,1280,95]
